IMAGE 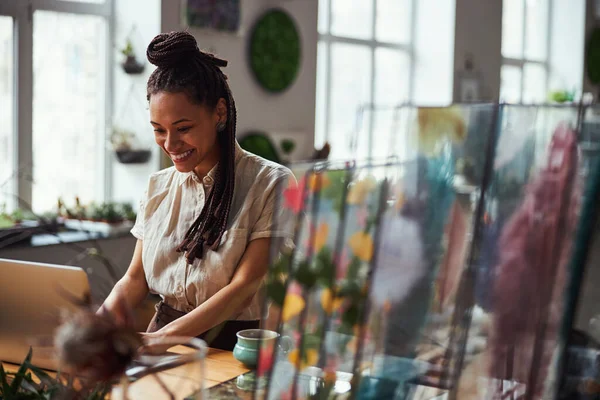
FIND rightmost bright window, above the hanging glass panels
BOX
[500,0,552,103]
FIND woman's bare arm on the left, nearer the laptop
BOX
[99,240,148,321]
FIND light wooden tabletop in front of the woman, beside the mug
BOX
[2,346,249,400]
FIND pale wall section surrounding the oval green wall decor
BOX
[161,0,318,150]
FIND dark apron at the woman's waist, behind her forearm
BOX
[146,301,260,351]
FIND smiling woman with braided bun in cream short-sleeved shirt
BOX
[103,32,294,350]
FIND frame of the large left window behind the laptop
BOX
[0,0,114,211]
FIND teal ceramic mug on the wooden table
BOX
[233,329,292,368]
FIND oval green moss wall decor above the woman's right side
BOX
[249,9,301,93]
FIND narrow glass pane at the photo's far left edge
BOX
[0,16,17,210]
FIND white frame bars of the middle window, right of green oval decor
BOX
[315,0,417,157]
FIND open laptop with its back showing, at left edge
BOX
[0,258,90,370]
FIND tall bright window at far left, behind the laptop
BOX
[0,0,113,212]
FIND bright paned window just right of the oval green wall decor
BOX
[315,0,414,159]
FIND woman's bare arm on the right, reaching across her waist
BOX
[147,238,270,338]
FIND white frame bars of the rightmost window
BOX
[500,0,553,103]
